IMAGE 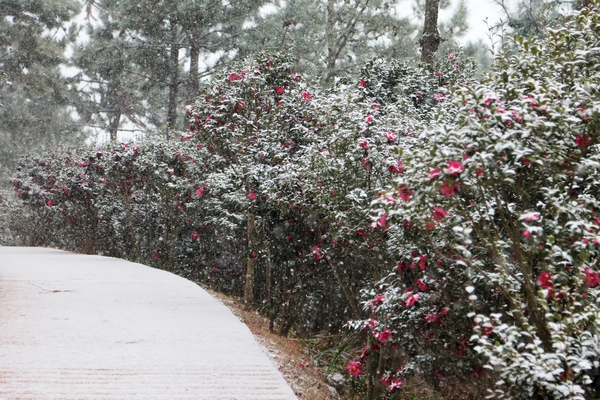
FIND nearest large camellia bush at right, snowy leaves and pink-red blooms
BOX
[348,3,600,399]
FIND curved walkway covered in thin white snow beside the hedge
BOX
[0,247,296,400]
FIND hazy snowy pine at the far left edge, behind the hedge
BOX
[0,0,81,173]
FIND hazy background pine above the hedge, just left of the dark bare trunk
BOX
[241,0,417,84]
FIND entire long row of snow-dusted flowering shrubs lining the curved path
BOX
[7,2,600,398]
